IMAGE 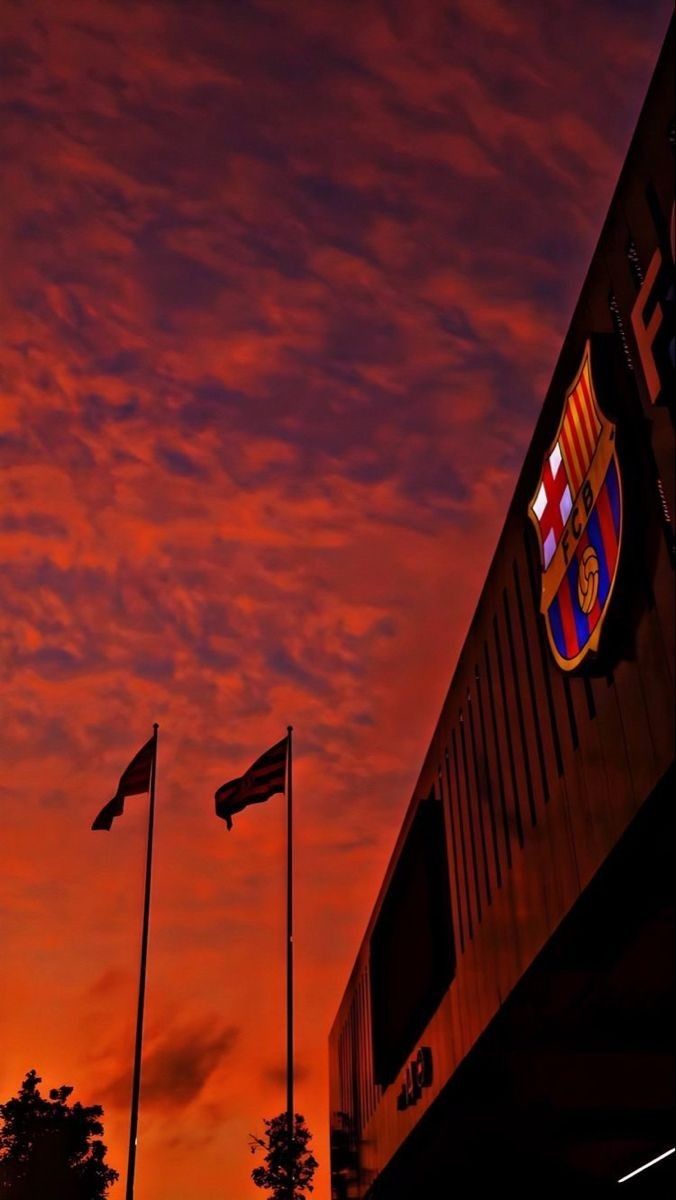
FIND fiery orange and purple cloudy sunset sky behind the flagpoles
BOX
[0,0,670,1200]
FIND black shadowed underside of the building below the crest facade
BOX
[369,769,676,1200]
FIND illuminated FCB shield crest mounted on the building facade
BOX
[528,342,622,671]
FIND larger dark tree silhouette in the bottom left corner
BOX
[0,1070,118,1200]
